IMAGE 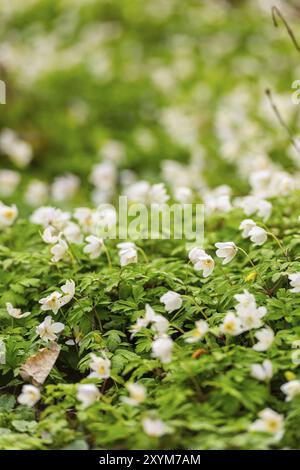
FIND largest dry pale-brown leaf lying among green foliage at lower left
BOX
[20,343,60,386]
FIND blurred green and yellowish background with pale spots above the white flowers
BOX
[0,0,300,206]
